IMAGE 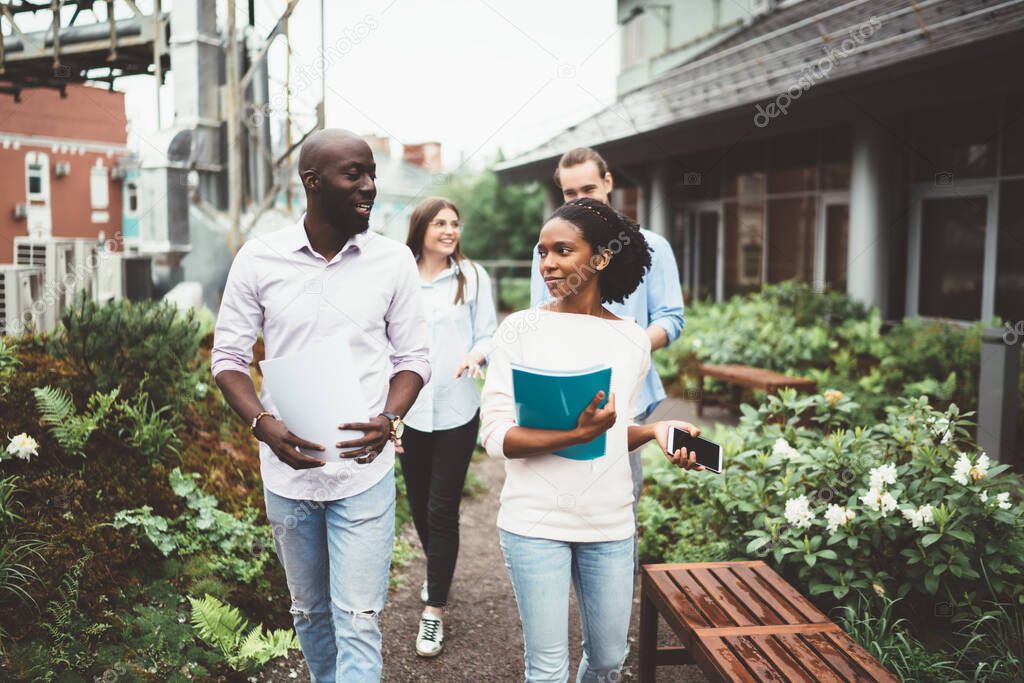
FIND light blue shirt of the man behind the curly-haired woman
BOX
[529,229,686,418]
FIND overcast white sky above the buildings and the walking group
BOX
[103,0,620,168]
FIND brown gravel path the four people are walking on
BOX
[261,448,706,683]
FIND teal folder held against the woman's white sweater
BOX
[512,364,611,460]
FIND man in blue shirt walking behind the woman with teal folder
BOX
[529,147,684,552]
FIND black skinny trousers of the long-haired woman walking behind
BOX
[398,412,480,607]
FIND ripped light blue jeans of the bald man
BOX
[263,470,394,683]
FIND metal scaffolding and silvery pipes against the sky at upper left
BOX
[0,0,324,251]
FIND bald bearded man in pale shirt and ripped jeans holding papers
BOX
[211,129,430,683]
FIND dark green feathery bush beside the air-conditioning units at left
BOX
[51,298,202,408]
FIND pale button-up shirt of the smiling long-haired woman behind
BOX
[404,261,498,432]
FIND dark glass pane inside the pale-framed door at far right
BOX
[918,197,988,321]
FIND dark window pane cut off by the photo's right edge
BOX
[995,180,1024,324]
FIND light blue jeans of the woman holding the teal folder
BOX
[500,529,633,683]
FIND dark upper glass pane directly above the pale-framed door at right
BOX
[913,99,999,184]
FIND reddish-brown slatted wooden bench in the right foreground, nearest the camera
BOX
[640,560,899,683]
